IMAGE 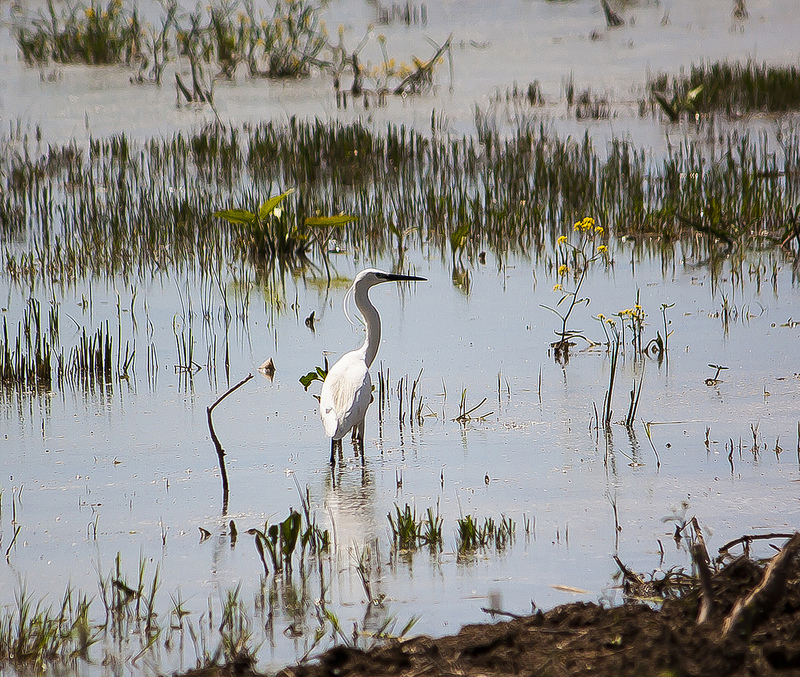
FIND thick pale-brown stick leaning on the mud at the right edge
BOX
[722,532,800,636]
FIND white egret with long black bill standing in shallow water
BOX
[319,268,425,464]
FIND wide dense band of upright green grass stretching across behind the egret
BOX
[6,119,800,294]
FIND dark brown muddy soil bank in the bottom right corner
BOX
[188,535,800,677]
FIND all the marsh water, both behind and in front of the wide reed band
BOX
[0,0,800,674]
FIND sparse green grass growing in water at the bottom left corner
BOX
[0,555,288,673]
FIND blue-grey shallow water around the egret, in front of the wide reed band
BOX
[0,244,800,667]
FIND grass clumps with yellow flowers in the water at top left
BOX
[14,0,452,109]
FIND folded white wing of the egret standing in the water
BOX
[319,351,372,440]
